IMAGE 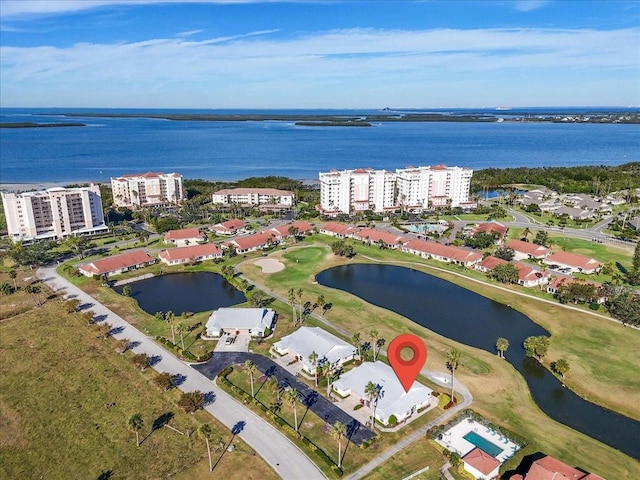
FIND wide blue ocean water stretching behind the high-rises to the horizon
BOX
[0,109,640,183]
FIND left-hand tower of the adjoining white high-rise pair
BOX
[320,168,396,215]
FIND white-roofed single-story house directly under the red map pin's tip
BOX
[333,362,433,425]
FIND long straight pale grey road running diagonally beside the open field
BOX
[38,266,326,480]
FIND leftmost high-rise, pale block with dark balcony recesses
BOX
[2,185,109,241]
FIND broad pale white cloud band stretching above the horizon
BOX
[0,25,640,107]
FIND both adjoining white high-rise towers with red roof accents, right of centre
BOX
[320,165,473,215]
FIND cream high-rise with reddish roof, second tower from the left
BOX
[111,172,184,210]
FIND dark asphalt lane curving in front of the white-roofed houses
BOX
[193,352,375,445]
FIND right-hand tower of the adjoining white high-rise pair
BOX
[396,165,473,212]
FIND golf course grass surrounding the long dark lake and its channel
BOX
[239,236,640,478]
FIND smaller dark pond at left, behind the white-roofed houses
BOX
[114,272,246,315]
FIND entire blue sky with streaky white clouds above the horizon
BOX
[0,0,640,109]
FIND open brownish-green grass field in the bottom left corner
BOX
[0,275,277,480]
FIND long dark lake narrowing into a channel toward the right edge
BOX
[316,264,640,459]
